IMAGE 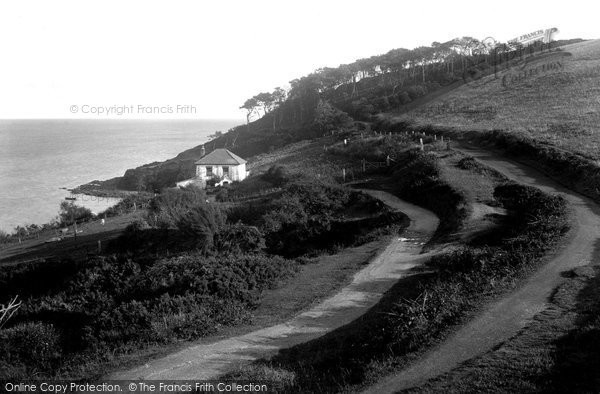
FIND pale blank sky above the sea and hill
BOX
[0,0,600,119]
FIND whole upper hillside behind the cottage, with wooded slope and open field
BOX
[80,40,600,194]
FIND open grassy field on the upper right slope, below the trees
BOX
[398,40,600,160]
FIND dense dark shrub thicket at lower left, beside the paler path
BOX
[0,253,297,379]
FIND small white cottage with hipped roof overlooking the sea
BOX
[195,148,248,187]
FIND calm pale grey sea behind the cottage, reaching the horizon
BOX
[0,119,242,233]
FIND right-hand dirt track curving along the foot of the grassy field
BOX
[365,148,600,393]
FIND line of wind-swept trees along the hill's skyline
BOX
[240,37,578,125]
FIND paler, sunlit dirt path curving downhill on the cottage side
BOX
[109,191,439,379]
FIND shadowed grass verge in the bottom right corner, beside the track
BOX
[405,265,600,393]
